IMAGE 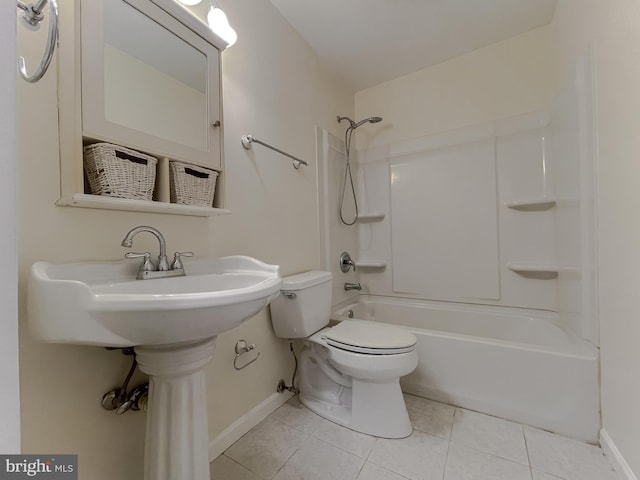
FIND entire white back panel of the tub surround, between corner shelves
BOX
[350,113,564,310]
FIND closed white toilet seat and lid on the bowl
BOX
[322,320,417,355]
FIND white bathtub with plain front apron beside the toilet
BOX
[331,295,600,442]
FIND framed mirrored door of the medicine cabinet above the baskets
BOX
[81,0,222,170]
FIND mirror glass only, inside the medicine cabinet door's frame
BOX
[104,0,208,150]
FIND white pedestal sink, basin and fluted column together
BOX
[27,256,282,480]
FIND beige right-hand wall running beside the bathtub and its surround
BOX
[552,0,640,476]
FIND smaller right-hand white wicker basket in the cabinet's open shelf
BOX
[169,160,219,207]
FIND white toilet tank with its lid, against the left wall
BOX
[270,270,332,338]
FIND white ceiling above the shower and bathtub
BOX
[271,0,557,91]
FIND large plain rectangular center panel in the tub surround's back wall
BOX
[390,138,500,300]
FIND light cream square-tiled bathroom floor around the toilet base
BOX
[211,395,619,480]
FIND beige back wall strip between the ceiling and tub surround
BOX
[355,27,553,149]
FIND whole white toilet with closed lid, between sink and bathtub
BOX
[271,271,418,438]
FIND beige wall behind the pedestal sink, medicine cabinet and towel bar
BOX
[18,0,353,480]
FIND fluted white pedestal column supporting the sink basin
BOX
[135,337,216,480]
